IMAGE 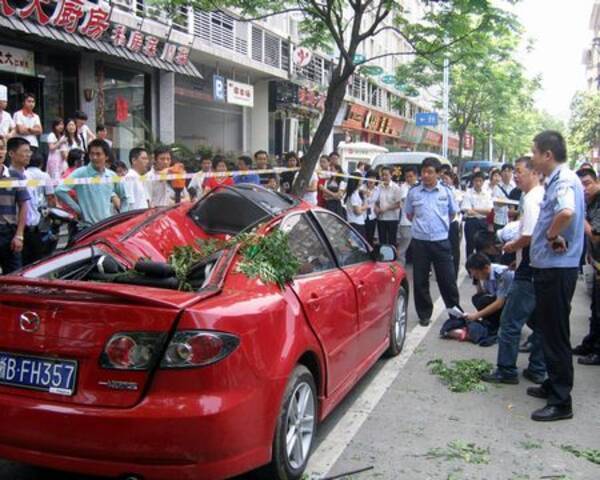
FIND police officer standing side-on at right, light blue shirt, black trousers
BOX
[527,131,585,421]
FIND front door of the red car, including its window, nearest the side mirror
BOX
[313,210,396,360]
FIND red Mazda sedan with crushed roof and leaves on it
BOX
[0,185,408,480]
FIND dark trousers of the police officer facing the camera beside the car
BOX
[412,238,460,320]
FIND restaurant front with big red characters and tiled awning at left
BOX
[0,0,201,163]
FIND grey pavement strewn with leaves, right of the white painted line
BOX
[324,280,600,480]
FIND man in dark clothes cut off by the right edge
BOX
[573,168,600,365]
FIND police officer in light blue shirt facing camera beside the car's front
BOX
[404,157,460,326]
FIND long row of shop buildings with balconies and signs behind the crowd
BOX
[0,0,457,164]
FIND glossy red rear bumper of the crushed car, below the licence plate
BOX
[0,382,284,480]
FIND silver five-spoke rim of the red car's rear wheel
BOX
[286,382,315,469]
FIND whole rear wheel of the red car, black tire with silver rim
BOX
[267,365,317,480]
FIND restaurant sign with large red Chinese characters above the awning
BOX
[0,0,190,65]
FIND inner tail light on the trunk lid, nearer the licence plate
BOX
[100,332,165,370]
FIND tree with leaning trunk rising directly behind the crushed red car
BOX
[154,0,514,194]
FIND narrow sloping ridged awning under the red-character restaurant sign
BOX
[0,16,203,78]
